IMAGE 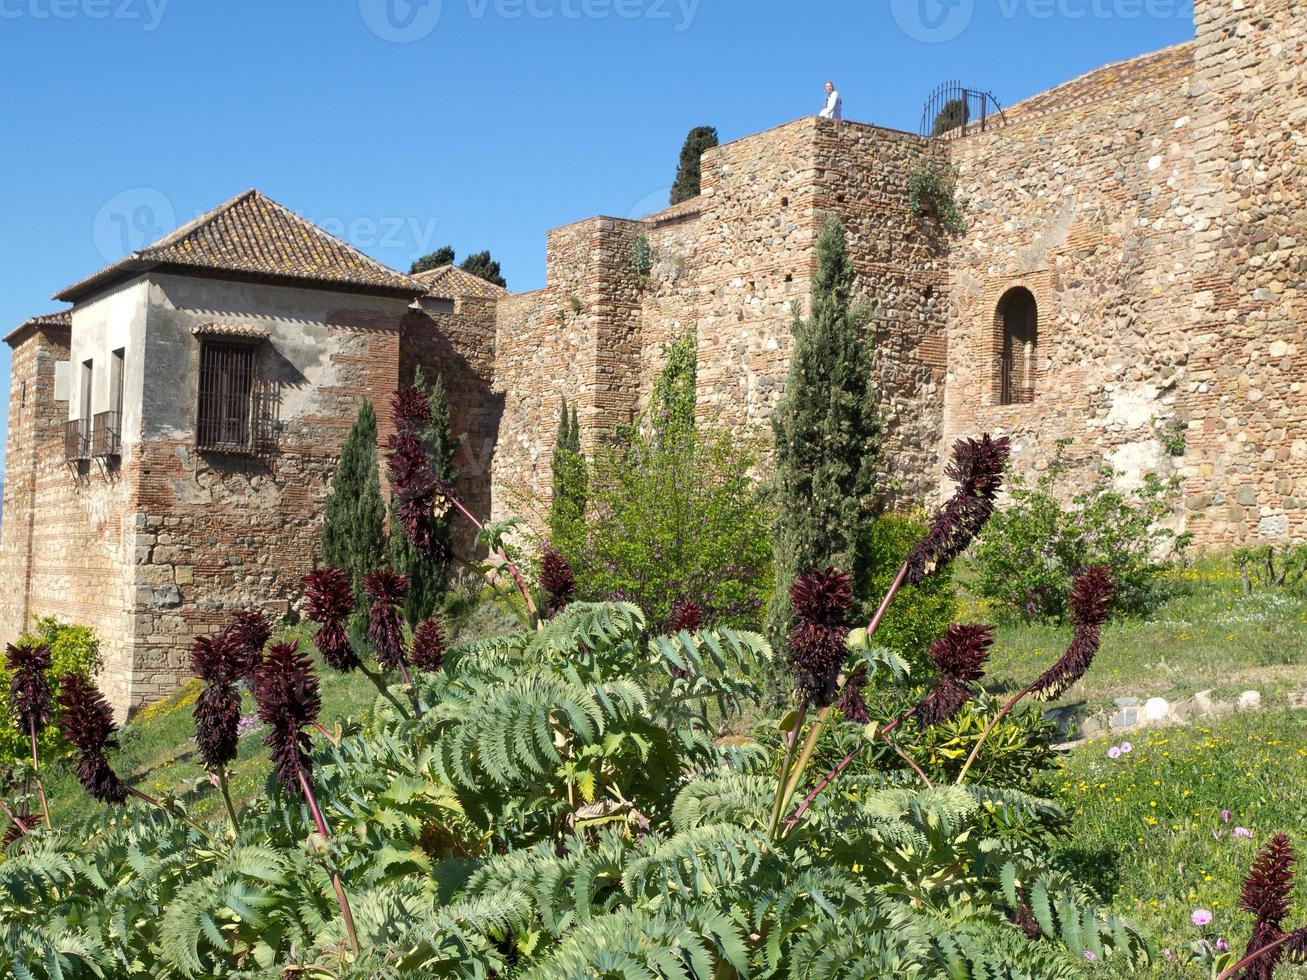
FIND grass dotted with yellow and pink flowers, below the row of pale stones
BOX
[1056,710,1307,977]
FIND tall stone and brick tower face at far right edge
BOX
[1184,0,1307,544]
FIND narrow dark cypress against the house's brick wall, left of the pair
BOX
[319,400,386,638]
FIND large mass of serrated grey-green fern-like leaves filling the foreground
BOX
[0,604,1148,980]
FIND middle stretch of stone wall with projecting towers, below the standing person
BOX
[493,119,948,517]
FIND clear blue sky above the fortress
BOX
[0,0,1193,473]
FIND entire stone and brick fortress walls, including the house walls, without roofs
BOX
[0,0,1307,711]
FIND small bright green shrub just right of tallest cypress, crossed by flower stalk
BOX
[859,511,958,666]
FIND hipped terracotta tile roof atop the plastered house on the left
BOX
[56,191,423,302]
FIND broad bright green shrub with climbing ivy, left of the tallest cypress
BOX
[555,337,770,629]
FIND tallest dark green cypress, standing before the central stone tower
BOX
[769,216,881,638]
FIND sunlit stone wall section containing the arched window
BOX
[944,46,1193,509]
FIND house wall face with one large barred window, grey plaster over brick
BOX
[127,276,406,707]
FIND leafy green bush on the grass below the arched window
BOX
[974,457,1188,621]
